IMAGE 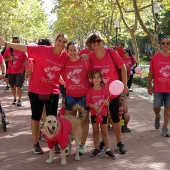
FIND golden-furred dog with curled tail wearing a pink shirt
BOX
[41,104,86,165]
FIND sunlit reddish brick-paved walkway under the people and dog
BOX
[0,82,170,170]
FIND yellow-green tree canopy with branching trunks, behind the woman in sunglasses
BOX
[54,0,170,59]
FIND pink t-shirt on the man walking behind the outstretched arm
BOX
[4,48,27,74]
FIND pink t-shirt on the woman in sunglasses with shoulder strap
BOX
[89,48,124,98]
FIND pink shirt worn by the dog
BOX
[46,116,72,150]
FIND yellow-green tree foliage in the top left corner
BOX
[0,0,49,41]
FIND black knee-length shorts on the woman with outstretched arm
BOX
[28,92,59,121]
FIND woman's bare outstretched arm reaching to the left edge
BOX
[0,36,27,52]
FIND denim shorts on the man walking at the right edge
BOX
[153,92,170,107]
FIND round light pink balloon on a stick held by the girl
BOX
[109,80,124,95]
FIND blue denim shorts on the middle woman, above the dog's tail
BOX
[65,94,89,111]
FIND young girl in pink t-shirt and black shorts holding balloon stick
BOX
[86,70,115,158]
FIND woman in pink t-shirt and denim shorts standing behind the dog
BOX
[62,42,92,154]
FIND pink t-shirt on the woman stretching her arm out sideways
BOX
[27,45,67,94]
